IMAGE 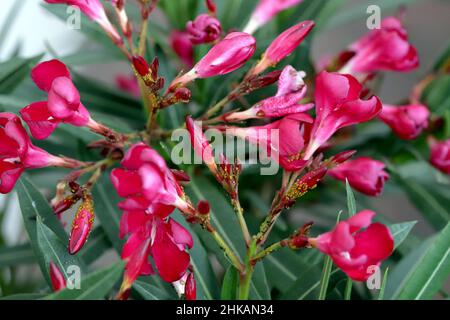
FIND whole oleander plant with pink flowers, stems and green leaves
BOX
[0,0,450,300]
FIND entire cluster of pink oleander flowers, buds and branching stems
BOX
[0,0,450,300]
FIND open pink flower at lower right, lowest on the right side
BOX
[309,210,394,281]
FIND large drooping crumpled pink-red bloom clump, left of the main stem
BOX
[111,143,193,292]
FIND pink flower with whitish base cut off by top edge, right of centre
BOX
[244,0,303,34]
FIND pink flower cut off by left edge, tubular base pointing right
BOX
[0,112,80,193]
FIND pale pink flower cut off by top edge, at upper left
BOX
[45,0,122,43]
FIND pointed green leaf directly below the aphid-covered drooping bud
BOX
[36,217,84,287]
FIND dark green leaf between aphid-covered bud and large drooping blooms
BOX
[92,174,123,253]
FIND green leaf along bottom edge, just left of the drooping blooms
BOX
[44,261,124,300]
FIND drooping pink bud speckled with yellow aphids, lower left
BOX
[69,194,95,254]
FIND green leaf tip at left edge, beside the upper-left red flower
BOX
[0,55,43,94]
